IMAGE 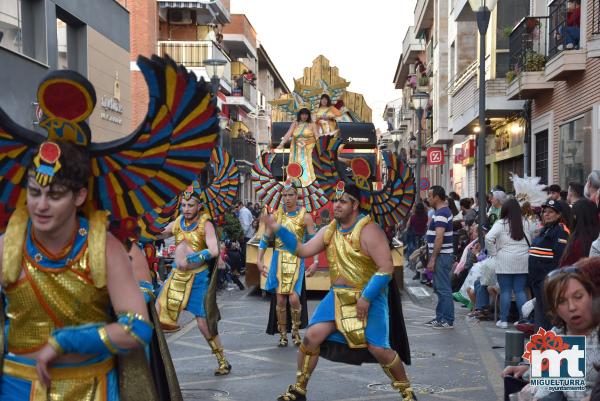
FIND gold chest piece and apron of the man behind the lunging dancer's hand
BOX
[275,208,306,294]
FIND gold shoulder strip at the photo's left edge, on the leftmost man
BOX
[2,207,29,285]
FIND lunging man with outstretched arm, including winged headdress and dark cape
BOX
[263,144,416,401]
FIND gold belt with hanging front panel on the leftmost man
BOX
[3,358,115,401]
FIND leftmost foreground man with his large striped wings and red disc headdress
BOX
[0,57,218,401]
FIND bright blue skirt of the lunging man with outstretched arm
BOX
[308,288,391,348]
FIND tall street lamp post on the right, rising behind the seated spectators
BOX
[469,0,498,244]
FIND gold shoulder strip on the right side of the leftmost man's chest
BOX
[88,211,107,288]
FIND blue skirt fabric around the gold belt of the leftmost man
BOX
[0,354,119,401]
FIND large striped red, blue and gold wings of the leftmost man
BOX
[0,56,219,232]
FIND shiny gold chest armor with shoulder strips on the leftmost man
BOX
[3,211,111,354]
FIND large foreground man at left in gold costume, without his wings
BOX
[0,141,152,401]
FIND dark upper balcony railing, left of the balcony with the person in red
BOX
[507,17,549,80]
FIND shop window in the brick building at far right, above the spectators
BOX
[558,111,592,188]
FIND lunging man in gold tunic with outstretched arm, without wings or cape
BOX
[264,185,416,401]
